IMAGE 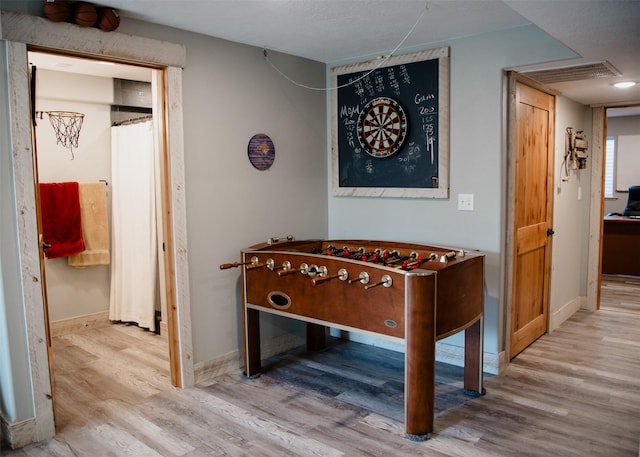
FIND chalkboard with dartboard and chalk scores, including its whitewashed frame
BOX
[332,48,449,198]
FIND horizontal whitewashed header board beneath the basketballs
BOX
[0,11,186,68]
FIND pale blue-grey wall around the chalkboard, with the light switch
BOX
[328,26,573,354]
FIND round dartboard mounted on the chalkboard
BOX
[357,97,409,158]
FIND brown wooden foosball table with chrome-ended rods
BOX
[220,236,484,441]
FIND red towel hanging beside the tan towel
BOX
[40,182,84,259]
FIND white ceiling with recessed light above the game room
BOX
[15,0,640,112]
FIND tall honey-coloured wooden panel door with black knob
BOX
[509,82,555,358]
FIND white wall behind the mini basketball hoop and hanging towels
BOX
[36,69,113,322]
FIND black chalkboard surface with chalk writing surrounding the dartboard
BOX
[334,48,448,198]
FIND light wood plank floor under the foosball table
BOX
[2,277,640,457]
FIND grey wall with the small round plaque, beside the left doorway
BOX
[111,21,327,363]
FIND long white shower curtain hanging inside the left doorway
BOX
[109,121,158,331]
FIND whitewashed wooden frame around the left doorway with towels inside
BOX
[0,11,194,442]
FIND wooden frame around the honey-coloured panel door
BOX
[503,71,556,365]
